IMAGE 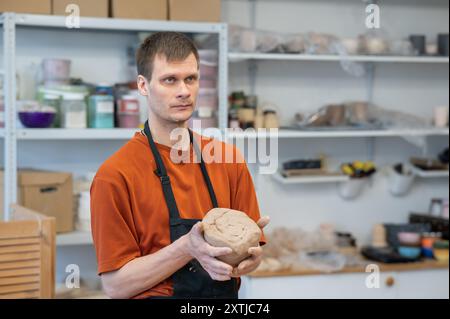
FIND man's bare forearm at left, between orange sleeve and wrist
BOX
[102,236,192,298]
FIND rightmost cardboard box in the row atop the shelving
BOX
[169,0,220,22]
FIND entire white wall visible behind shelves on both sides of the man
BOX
[1,0,449,290]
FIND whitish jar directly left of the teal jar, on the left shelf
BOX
[61,93,87,128]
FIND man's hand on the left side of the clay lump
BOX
[185,222,233,281]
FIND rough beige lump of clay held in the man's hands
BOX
[203,208,261,267]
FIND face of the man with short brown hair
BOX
[148,54,199,124]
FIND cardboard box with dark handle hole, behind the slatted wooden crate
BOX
[18,170,75,233]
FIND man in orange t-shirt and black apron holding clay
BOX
[91,32,268,298]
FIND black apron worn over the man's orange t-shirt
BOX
[144,121,238,299]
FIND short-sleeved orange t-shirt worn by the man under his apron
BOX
[91,133,264,298]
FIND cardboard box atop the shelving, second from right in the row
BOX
[111,0,168,20]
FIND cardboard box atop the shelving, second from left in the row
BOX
[52,0,109,18]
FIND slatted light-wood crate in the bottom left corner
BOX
[0,205,56,299]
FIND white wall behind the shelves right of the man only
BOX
[223,0,449,244]
